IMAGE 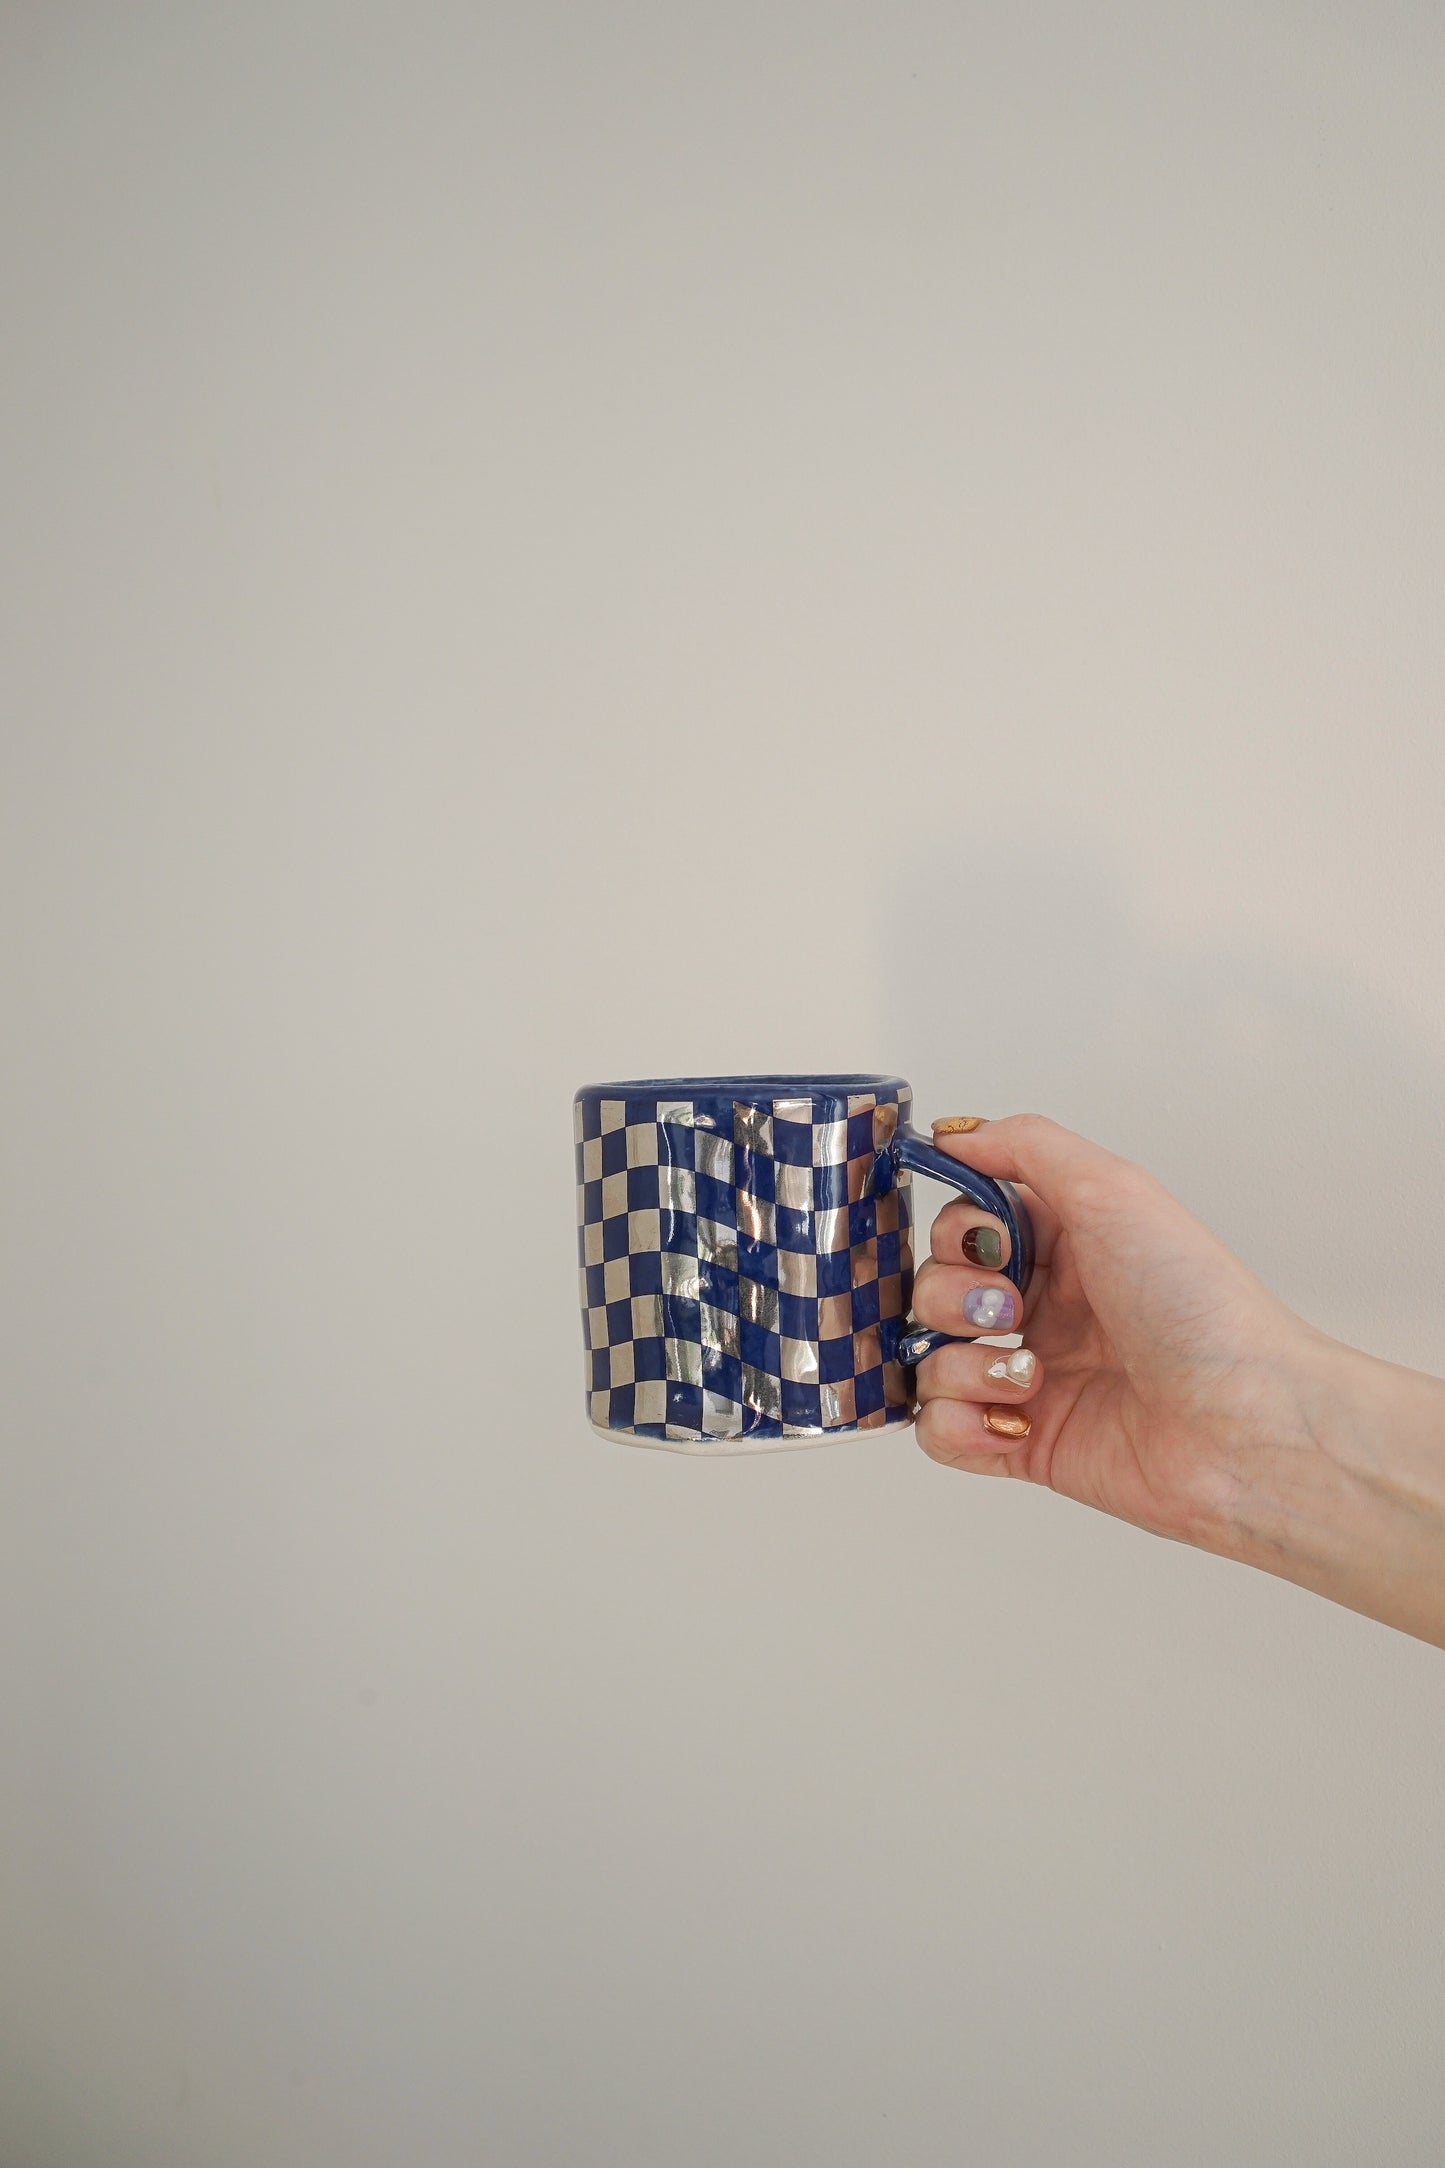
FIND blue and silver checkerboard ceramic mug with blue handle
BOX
[572,1075,1033,1453]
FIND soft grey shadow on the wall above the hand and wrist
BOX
[880,846,1445,1372]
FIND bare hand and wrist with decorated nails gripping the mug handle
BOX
[914,1114,1445,1648]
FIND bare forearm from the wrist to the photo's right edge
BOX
[1228,1335,1445,1648]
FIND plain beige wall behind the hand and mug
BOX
[0,0,1445,2168]
